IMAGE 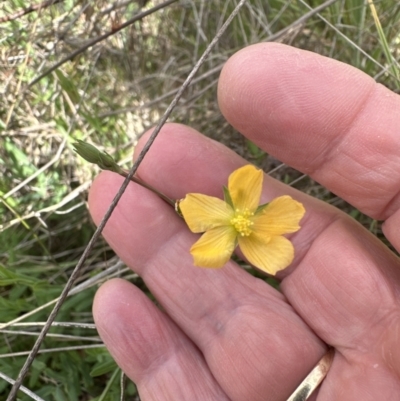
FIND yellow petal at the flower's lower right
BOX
[239,233,294,275]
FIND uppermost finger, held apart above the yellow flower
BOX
[218,43,400,219]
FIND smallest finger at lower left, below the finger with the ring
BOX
[93,279,228,401]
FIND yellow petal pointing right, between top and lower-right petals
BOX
[252,196,305,237]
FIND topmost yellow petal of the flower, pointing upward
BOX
[228,164,263,211]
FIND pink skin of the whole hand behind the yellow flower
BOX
[89,43,400,401]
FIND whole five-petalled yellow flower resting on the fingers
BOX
[179,165,305,274]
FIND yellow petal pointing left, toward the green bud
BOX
[179,194,233,233]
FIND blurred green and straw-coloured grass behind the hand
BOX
[0,0,400,401]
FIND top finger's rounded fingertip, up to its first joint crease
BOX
[218,43,375,161]
